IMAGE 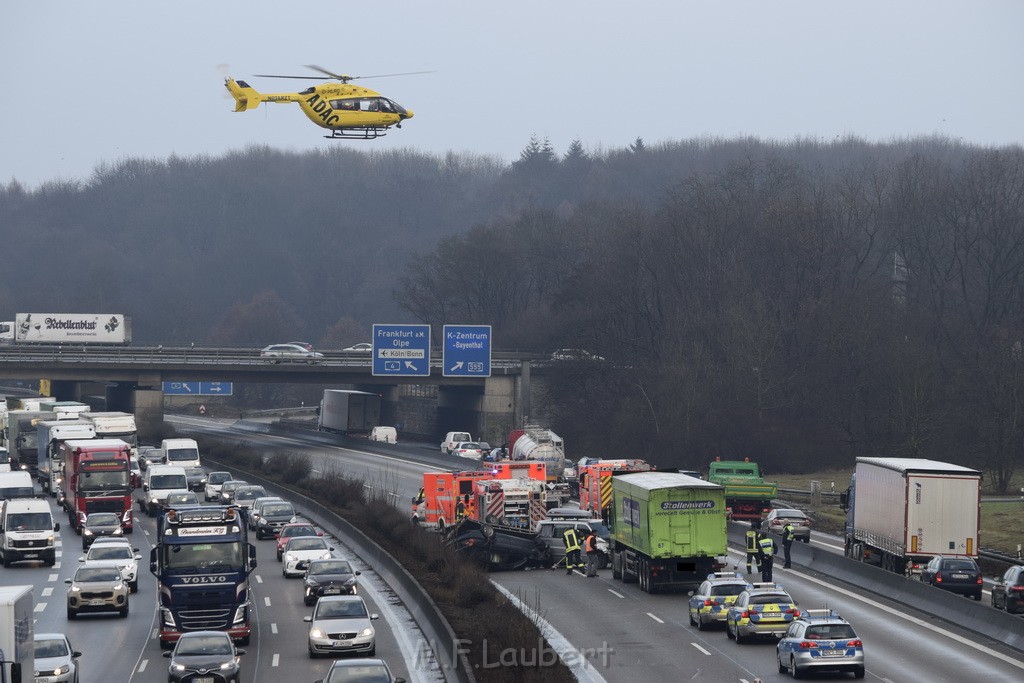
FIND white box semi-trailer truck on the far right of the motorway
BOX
[840,458,981,574]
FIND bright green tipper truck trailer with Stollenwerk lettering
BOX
[609,472,728,593]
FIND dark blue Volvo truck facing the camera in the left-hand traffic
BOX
[150,506,256,648]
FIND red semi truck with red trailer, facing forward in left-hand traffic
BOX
[60,438,132,533]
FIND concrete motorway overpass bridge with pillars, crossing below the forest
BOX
[0,344,548,437]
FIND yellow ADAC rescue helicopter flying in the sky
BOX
[224,65,431,140]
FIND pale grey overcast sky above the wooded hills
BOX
[0,0,1024,187]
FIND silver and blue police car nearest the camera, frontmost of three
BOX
[775,609,864,678]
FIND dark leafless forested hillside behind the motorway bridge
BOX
[0,138,1024,486]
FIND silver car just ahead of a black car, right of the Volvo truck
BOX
[302,595,377,658]
